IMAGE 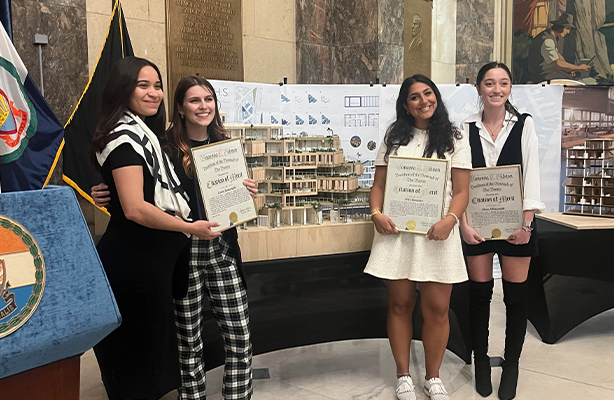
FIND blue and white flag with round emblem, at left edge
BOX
[0,24,64,192]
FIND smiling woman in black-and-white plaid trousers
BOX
[92,76,258,400]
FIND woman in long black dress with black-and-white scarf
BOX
[92,57,217,400]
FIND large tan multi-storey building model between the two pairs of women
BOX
[225,124,368,226]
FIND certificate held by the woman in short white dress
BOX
[383,156,448,234]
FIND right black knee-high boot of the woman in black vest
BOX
[499,280,528,400]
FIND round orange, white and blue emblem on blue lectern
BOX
[0,215,45,339]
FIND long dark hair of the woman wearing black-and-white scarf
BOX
[90,56,166,169]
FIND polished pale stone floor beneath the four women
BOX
[81,281,614,400]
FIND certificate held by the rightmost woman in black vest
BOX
[466,165,523,240]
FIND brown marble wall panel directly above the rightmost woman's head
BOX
[456,0,495,83]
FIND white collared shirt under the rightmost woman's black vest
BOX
[461,111,546,213]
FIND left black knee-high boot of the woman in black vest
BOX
[469,280,494,397]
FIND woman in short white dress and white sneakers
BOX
[365,75,471,400]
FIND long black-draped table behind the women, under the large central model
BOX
[203,251,471,370]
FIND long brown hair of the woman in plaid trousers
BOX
[167,76,228,176]
